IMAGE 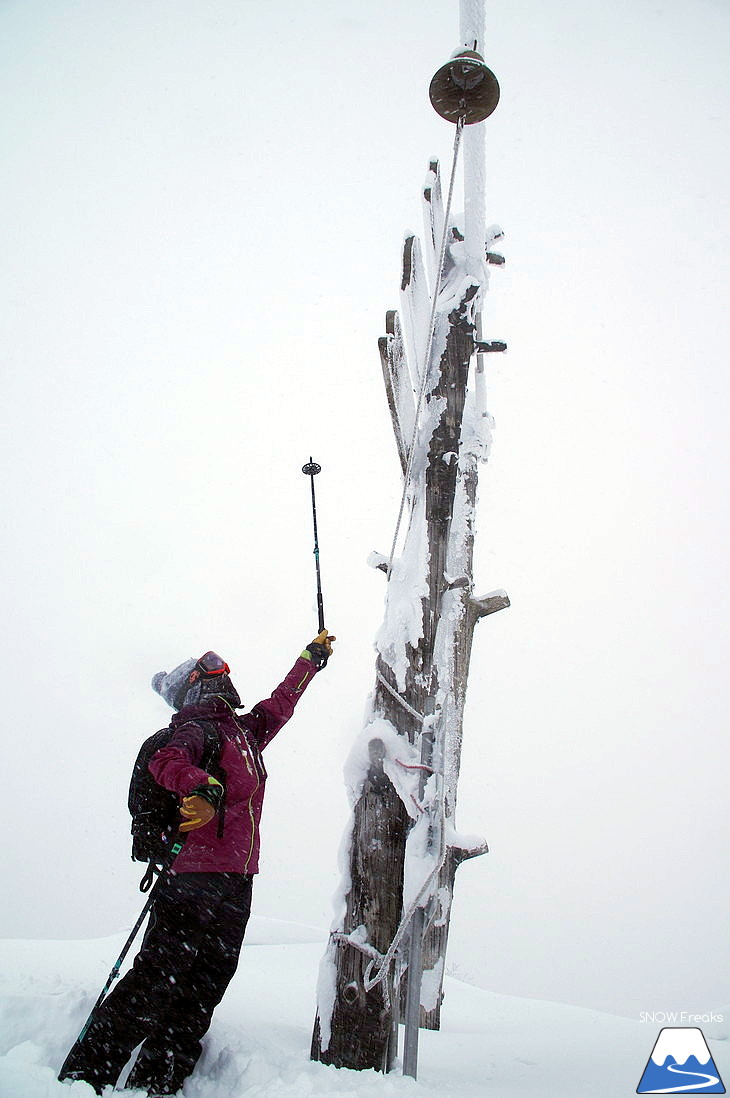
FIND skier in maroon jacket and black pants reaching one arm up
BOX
[58,629,336,1098]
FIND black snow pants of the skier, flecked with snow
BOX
[58,873,252,1095]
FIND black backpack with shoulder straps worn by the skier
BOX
[127,720,225,865]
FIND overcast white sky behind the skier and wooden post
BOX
[0,0,730,1016]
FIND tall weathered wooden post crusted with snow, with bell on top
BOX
[312,0,509,1076]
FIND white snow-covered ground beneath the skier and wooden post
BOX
[0,917,730,1098]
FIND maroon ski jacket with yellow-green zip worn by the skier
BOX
[149,657,317,873]
